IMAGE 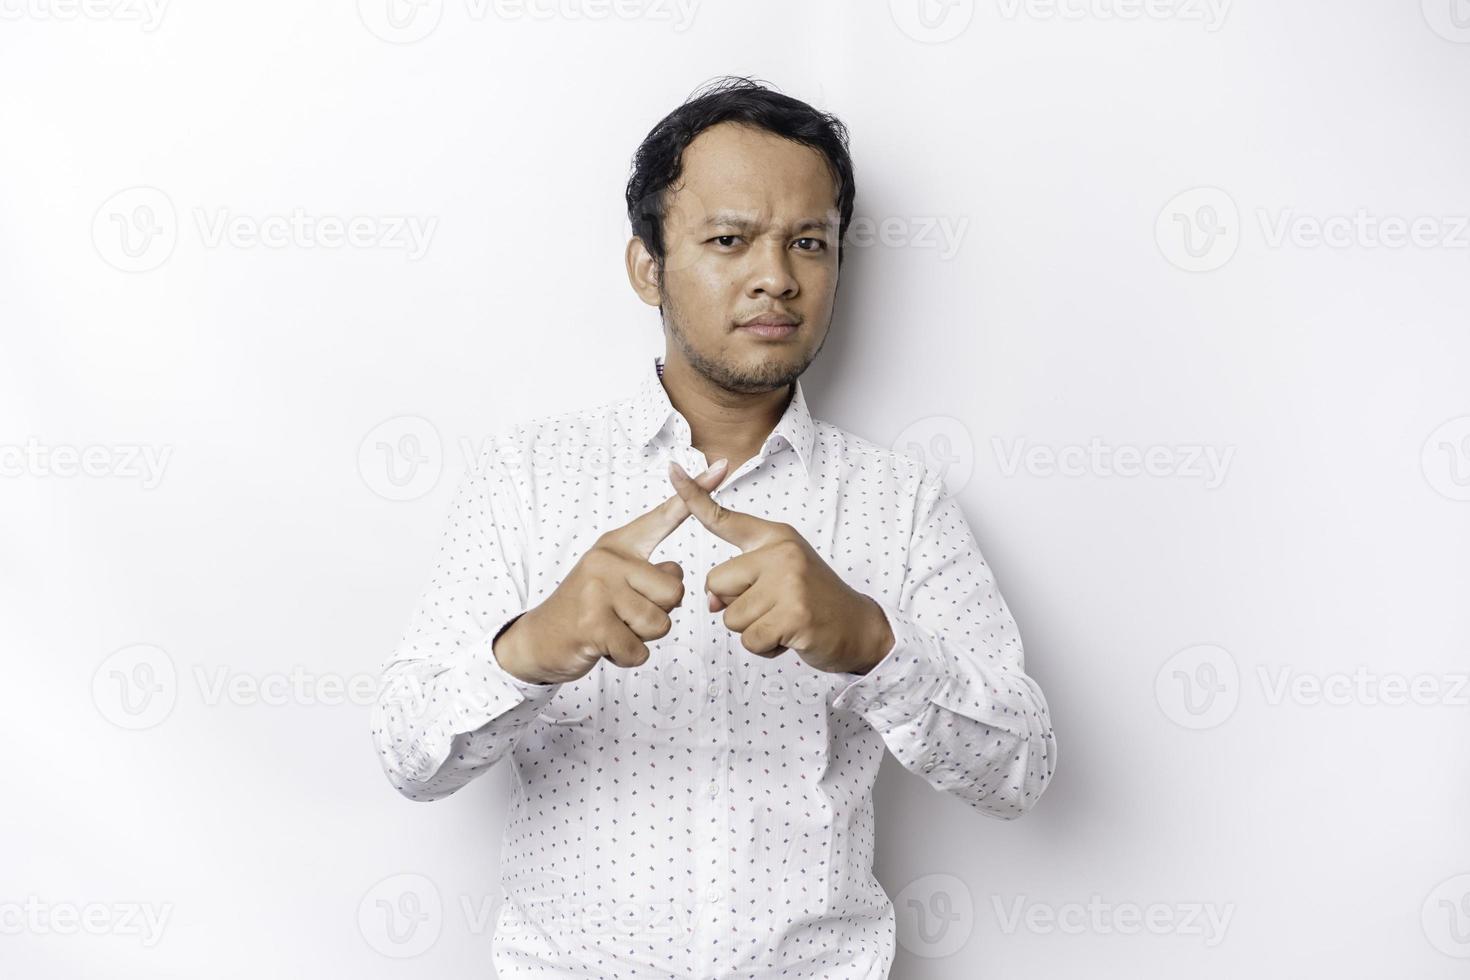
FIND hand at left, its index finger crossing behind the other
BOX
[491,460,728,683]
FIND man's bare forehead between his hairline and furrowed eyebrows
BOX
[669,122,836,222]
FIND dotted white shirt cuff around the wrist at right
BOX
[832,599,951,732]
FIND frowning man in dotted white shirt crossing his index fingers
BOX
[373,72,1057,980]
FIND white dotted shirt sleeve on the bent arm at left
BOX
[372,453,560,801]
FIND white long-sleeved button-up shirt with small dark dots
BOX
[372,359,1057,980]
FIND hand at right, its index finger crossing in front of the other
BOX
[669,463,895,674]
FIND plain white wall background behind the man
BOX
[0,0,1470,980]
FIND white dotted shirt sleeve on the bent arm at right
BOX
[833,470,1057,820]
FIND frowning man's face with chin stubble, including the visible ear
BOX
[628,122,839,392]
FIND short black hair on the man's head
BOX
[623,75,857,272]
